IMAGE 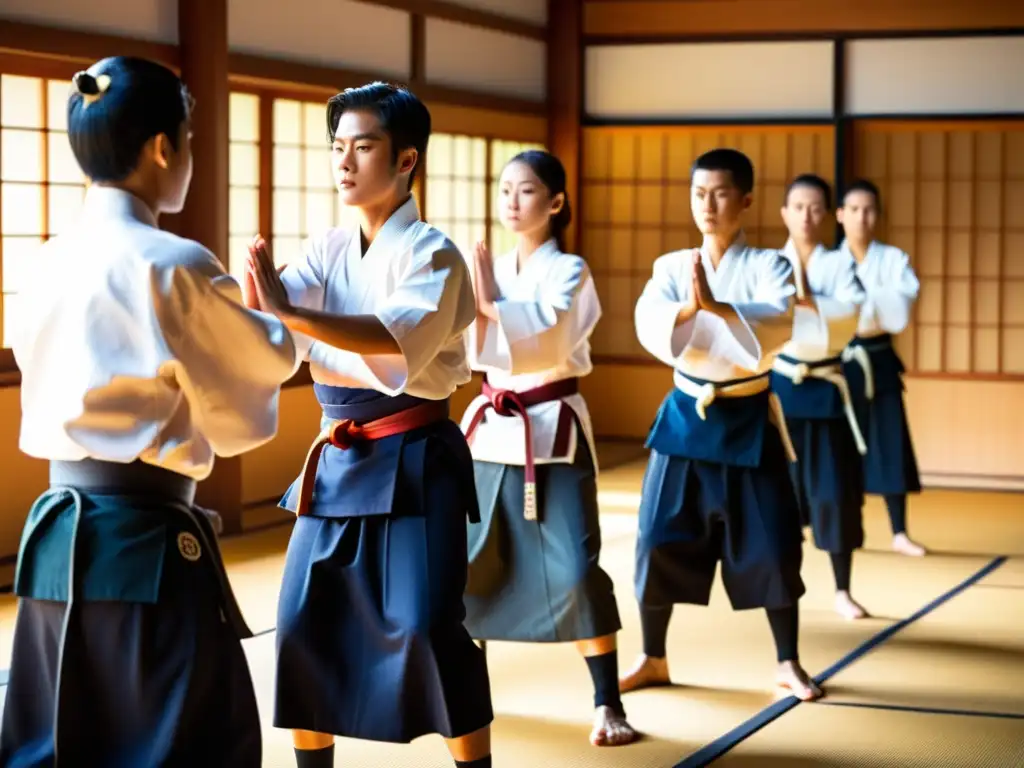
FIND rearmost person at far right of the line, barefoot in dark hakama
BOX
[837,179,926,557]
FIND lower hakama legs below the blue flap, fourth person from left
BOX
[635,428,804,610]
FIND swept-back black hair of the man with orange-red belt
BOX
[327,81,430,188]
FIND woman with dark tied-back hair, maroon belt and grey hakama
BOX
[463,151,637,745]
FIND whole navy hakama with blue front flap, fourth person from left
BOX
[635,382,804,610]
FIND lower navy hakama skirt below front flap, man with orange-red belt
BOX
[273,422,493,743]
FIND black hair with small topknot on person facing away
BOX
[68,56,193,182]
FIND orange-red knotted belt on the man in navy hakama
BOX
[295,400,449,516]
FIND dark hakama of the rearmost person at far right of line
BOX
[844,337,921,496]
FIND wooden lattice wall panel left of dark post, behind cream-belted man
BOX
[581,126,835,360]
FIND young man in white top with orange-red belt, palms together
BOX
[246,83,493,768]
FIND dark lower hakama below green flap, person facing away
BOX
[0,583,262,768]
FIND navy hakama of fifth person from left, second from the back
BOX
[772,355,864,554]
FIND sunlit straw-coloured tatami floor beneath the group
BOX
[0,449,1024,768]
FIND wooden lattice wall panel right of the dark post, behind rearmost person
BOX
[854,120,1024,377]
